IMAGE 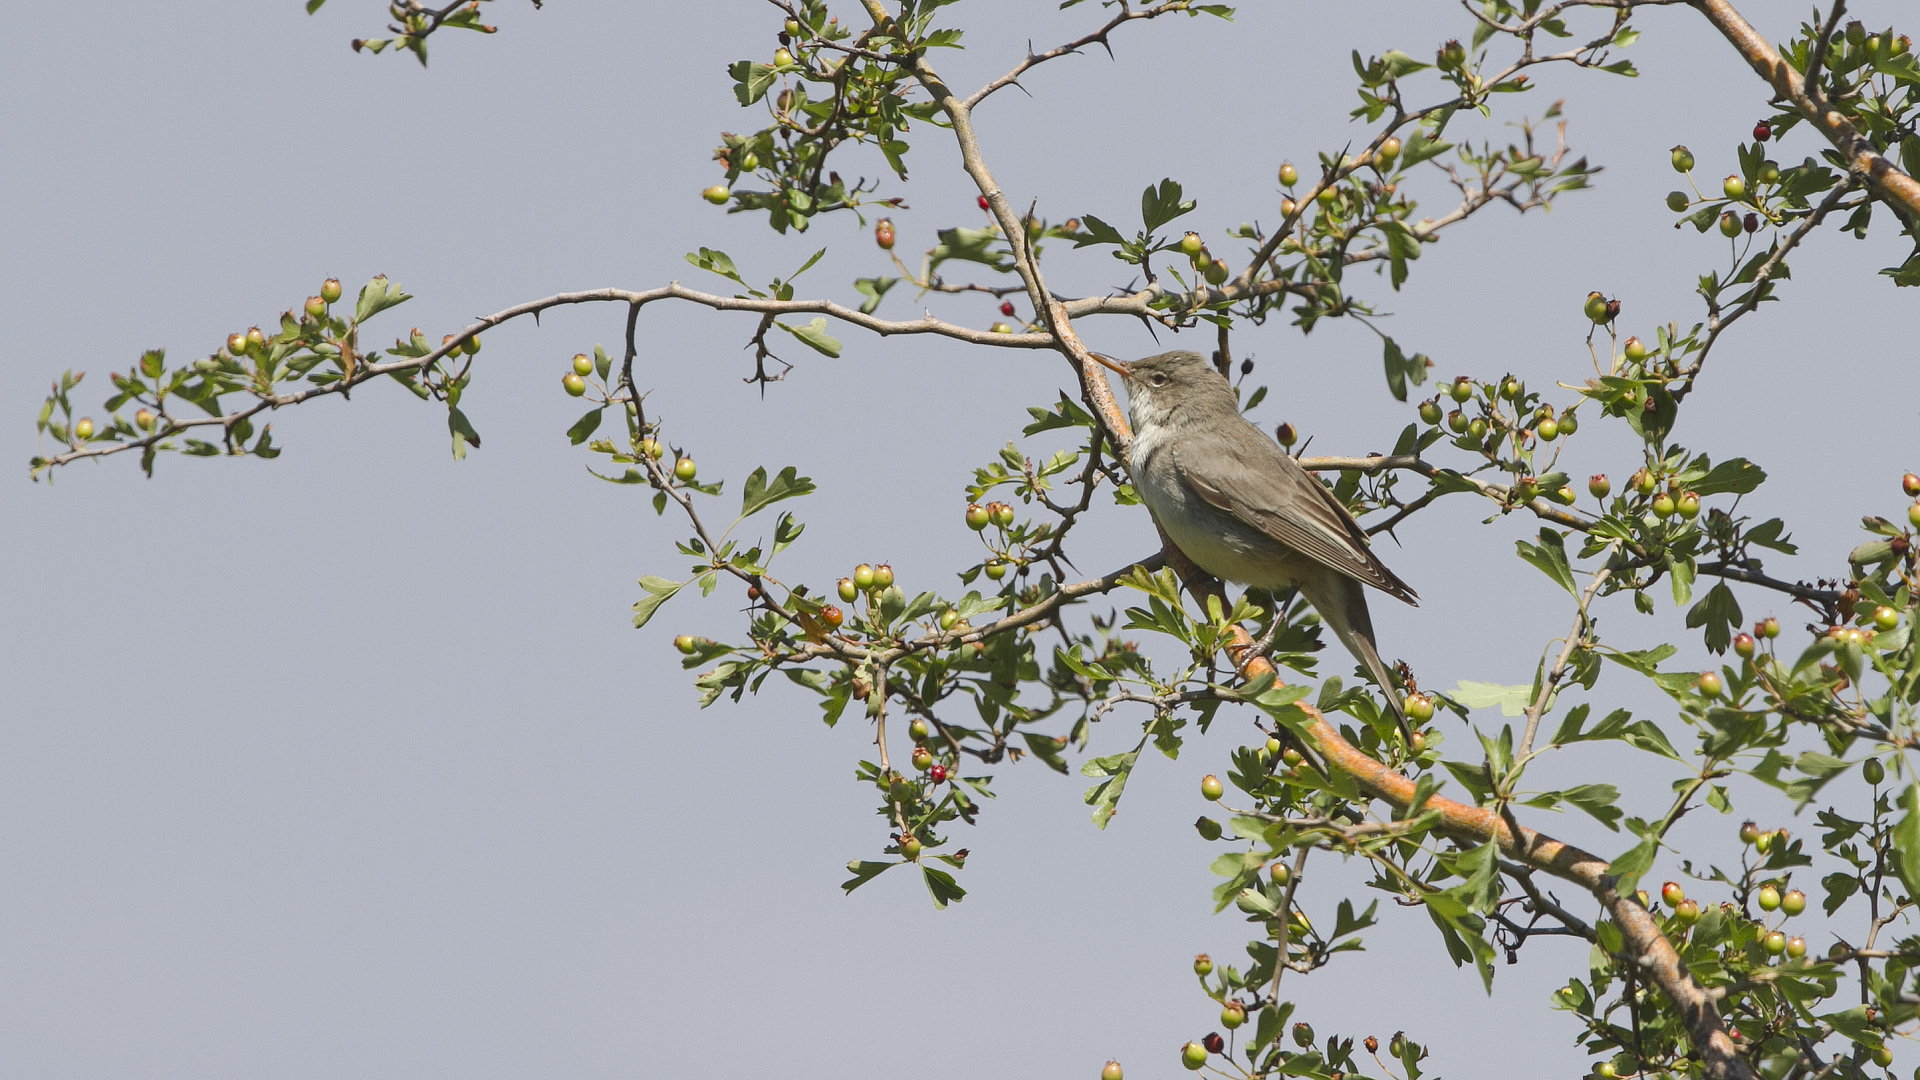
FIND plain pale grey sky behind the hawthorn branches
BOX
[0,0,1920,1080]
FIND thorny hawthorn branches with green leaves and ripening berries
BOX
[31,0,1920,1080]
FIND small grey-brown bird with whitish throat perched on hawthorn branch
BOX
[1098,352,1419,732]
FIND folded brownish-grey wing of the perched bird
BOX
[1173,417,1419,603]
